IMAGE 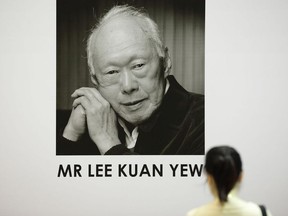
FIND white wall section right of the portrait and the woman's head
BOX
[206,0,288,215]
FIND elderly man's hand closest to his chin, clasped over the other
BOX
[69,87,120,154]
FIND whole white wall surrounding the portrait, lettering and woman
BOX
[0,0,288,216]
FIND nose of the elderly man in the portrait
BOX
[120,70,139,94]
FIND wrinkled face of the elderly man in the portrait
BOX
[93,18,166,125]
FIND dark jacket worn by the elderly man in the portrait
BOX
[56,76,205,155]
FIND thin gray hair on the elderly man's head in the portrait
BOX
[87,5,165,76]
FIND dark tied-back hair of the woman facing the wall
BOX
[205,146,242,202]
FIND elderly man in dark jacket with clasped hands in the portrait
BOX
[57,5,204,155]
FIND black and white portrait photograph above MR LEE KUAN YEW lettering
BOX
[57,0,205,155]
